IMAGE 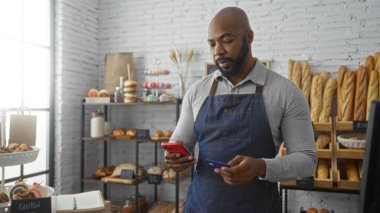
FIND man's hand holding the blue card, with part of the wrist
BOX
[214,155,266,185]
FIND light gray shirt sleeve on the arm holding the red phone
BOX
[170,90,195,152]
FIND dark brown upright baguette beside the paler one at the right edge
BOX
[354,66,368,121]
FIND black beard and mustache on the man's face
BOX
[214,37,249,77]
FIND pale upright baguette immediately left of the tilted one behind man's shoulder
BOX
[310,75,322,122]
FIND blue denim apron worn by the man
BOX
[184,80,281,213]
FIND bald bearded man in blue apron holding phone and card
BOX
[165,7,317,213]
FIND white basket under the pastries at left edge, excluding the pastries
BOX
[0,146,40,167]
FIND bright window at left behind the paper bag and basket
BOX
[0,0,54,184]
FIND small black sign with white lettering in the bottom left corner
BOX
[11,197,51,213]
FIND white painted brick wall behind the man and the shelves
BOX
[56,0,380,213]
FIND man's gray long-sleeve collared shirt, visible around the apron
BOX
[171,60,317,182]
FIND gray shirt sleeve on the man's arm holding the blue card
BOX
[261,84,318,182]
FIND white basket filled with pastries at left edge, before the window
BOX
[0,143,40,166]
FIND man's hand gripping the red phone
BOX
[165,152,198,172]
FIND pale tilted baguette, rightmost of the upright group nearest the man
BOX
[319,78,337,123]
